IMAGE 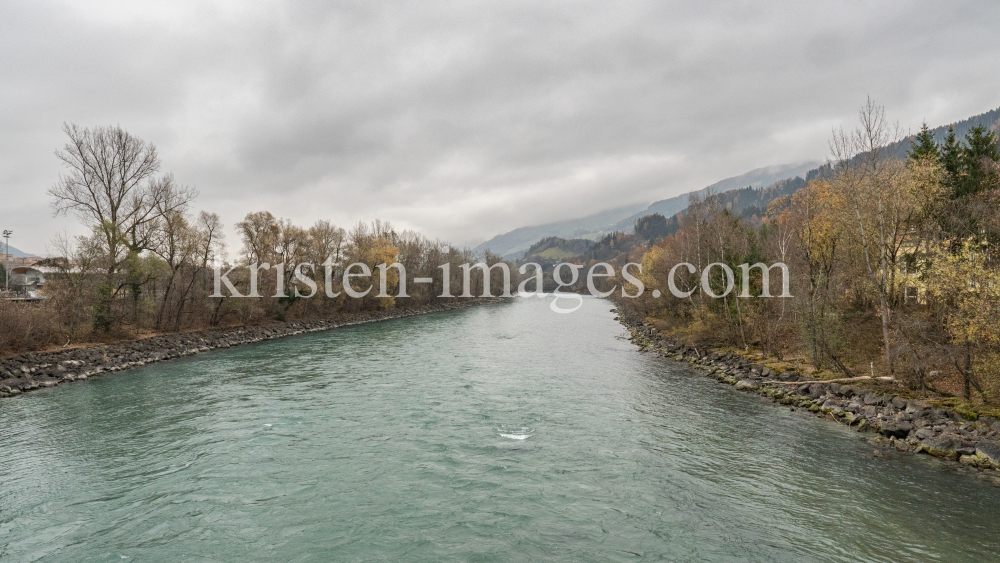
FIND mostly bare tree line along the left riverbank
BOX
[0,125,502,352]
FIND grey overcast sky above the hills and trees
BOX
[0,0,1000,253]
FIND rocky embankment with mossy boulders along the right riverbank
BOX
[619,308,1000,471]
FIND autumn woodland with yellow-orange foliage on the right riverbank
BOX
[615,102,1000,410]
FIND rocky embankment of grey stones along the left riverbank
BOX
[0,297,502,397]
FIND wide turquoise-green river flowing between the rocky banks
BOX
[0,298,1000,563]
